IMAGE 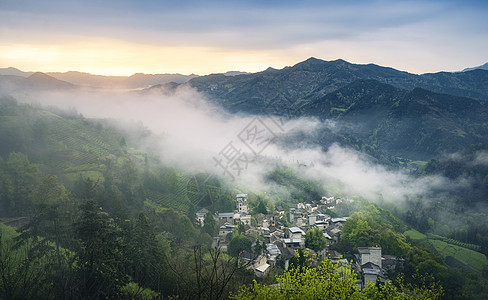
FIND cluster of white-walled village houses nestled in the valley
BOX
[197,194,403,289]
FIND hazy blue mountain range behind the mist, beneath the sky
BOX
[0,58,488,164]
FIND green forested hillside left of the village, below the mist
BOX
[0,98,248,299]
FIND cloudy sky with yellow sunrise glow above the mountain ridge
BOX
[0,0,488,75]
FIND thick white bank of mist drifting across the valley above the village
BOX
[8,85,472,206]
